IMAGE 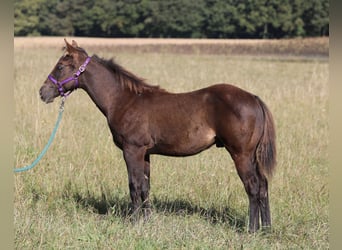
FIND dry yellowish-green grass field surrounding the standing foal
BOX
[14,38,329,249]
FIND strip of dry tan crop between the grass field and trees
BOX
[15,37,329,57]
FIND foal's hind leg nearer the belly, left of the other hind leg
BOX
[233,154,260,233]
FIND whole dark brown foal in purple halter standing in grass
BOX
[40,40,276,232]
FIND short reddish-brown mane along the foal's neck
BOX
[93,55,165,94]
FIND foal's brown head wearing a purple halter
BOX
[39,39,90,103]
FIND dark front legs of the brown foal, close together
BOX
[123,145,149,221]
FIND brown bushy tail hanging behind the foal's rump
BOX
[256,97,277,177]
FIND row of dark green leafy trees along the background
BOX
[14,0,329,38]
